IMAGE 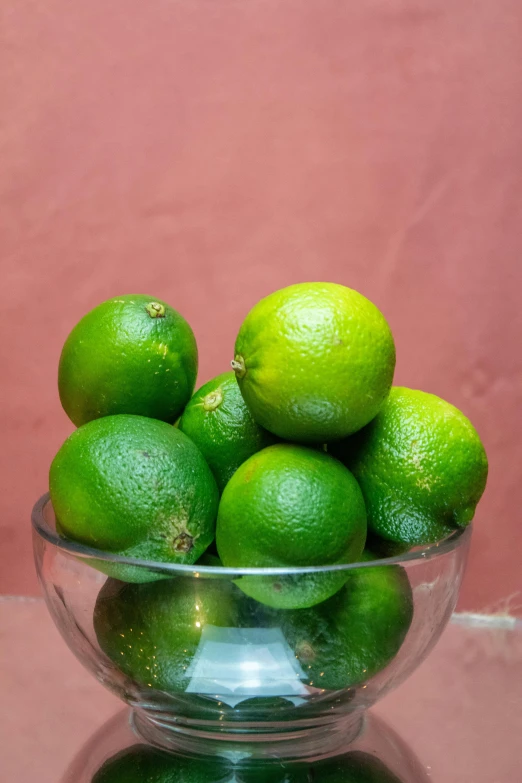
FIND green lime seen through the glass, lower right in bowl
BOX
[272,566,413,690]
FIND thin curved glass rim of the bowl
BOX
[31,492,472,577]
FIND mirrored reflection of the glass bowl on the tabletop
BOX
[60,710,430,783]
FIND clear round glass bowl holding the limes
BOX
[32,495,471,759]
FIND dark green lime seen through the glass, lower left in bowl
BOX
[94,577,241,693]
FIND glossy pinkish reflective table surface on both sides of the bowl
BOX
[0,597,522,783]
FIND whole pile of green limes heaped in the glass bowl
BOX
[49,283,487,691]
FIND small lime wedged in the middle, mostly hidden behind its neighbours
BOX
[178,372,276,492]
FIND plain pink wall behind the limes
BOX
[0,0,522,611]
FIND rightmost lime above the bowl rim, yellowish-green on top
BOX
[331,387,488,545]
